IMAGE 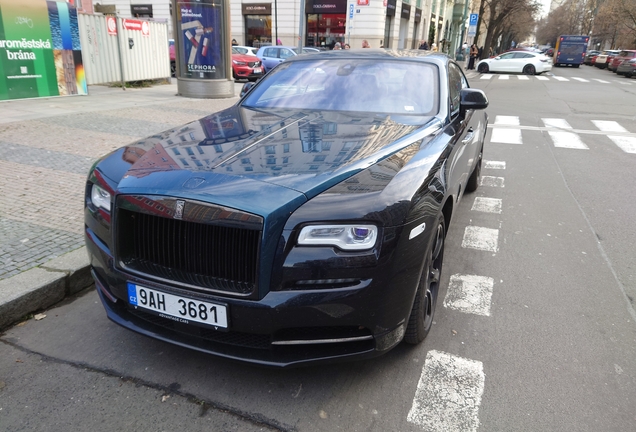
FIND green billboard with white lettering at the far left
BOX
[0,0,87,100]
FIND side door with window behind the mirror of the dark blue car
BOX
[447,63,483,201]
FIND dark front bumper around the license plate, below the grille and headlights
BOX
[86,228,418,367]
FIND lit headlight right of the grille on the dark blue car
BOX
[298,225,378,251]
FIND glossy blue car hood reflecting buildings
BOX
[109,106,438,198]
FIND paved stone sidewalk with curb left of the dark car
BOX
[0,83,242,328]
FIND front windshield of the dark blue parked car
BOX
[242,58,439,116]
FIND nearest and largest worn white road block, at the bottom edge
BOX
[407,351,486,432]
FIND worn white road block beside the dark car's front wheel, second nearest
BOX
[444,275,495,316]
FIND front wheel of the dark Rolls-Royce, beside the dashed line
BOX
[404,213,446,345]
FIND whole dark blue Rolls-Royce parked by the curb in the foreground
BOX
[85,49,488,367]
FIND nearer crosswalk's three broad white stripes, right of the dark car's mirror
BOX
[488,115,636,154]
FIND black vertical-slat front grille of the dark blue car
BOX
[115,196,262,296]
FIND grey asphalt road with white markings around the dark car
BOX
[0,67,636,431]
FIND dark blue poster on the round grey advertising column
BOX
[177,0,226,79]
